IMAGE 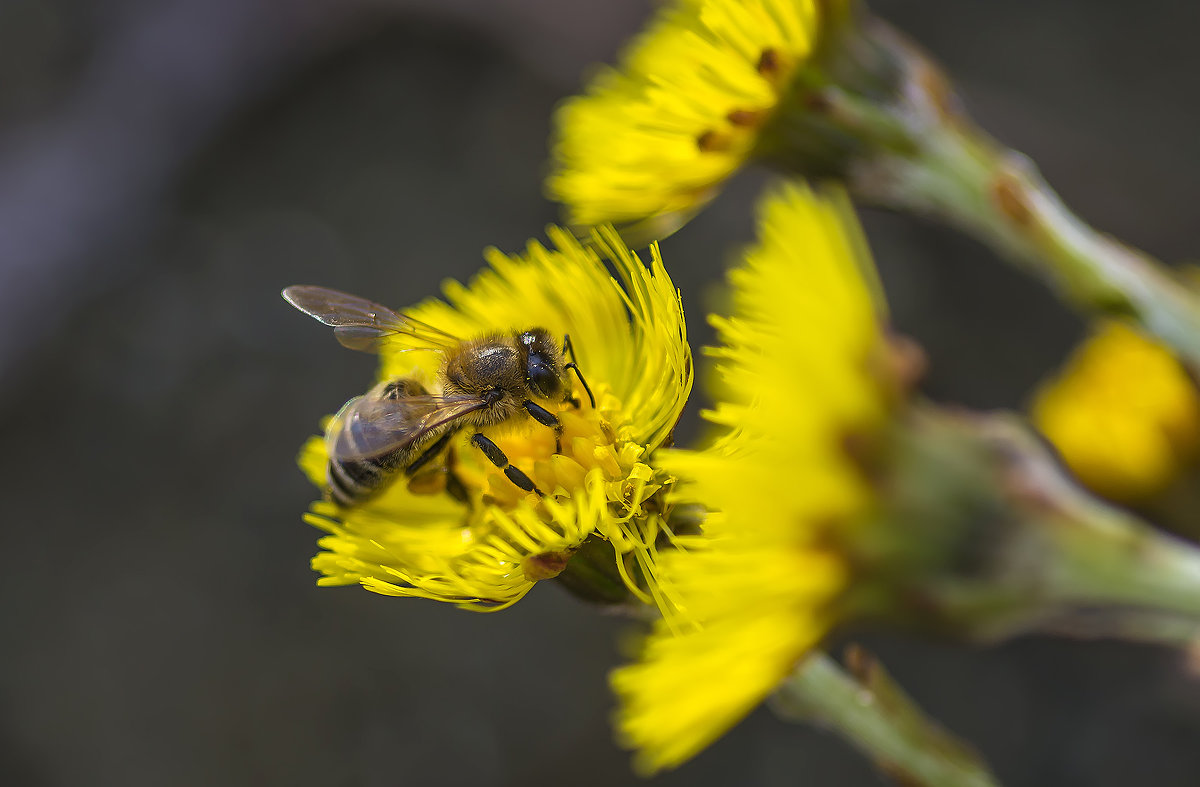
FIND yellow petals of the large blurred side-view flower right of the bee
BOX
[612,186,894,773]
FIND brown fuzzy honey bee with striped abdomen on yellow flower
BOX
[283,284,595,507]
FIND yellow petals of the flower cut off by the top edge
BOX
[546,0,847,238]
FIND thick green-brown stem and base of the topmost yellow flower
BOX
[757,16,1200,370]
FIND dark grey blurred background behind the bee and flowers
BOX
[0,0,1200,787]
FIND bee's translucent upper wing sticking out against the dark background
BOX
[283,284,460,353]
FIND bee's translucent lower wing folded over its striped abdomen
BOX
[325,395,487,462]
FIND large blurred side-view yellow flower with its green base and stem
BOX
[612,185,1200,773]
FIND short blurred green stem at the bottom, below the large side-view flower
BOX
[772,649,998,787]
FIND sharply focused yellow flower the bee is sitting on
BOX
[300,228,692,611]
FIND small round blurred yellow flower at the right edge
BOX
[1033,322,1200,503]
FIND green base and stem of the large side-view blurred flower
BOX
[853,407,1200,645]
